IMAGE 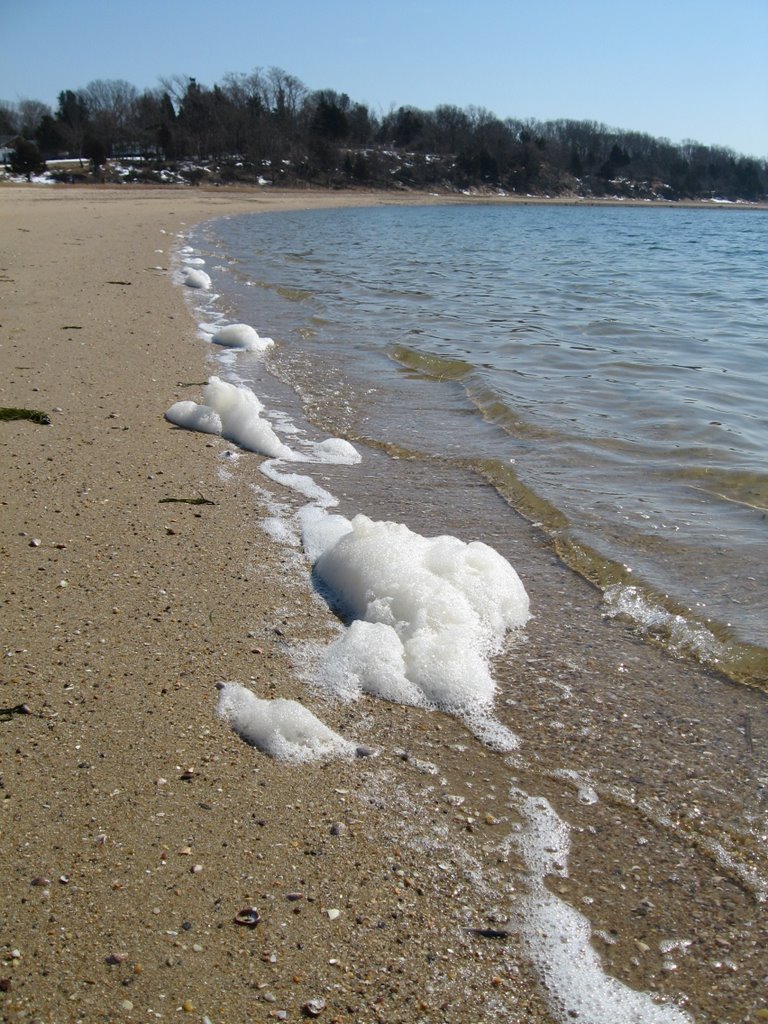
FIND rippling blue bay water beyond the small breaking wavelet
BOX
[198,206,768,686]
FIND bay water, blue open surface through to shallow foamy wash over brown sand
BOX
[182,201,768,1024]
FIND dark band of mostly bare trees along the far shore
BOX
[0,68,768,202]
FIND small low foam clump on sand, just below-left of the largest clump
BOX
[216,683,356,762]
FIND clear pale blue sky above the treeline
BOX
[0,0,768,158]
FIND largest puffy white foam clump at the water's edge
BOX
[302,511,528,749]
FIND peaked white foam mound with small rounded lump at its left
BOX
[165,377,295,460]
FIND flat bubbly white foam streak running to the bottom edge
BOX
[518,794,692,1024]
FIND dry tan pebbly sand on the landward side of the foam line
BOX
[0,187,549,1024]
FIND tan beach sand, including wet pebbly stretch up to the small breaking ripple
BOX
[0,187,768,1024]
